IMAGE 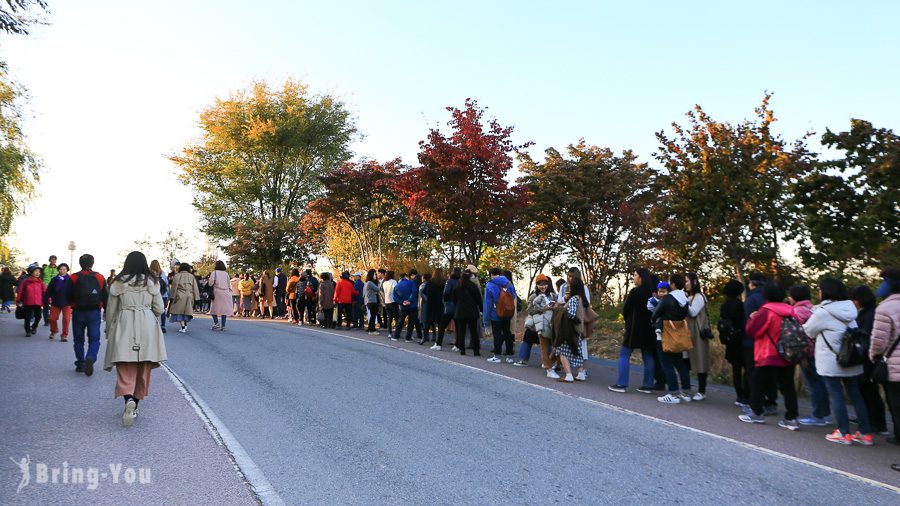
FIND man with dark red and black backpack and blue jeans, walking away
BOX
[69,254,107,376]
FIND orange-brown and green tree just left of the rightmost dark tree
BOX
[651,94,814,281]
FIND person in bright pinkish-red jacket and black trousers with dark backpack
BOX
[738,280,804,431]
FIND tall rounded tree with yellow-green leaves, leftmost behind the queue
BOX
[170,80,356,268]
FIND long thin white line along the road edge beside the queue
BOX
[300,327,900,494]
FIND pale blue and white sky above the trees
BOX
[0,0,900,268]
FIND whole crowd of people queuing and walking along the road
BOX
[0,252,900,466]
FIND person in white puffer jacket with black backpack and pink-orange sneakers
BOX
[803,278,873,446]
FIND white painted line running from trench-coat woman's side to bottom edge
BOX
[162,363,284,506]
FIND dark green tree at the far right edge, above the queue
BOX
[793,119,900,276]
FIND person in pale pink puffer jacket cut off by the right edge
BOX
[869,267,900,450]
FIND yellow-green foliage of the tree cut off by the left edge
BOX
[0,63,40,236]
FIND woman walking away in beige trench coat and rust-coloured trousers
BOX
[103,251,166,427]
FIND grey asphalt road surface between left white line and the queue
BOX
[167,319,900,505]
